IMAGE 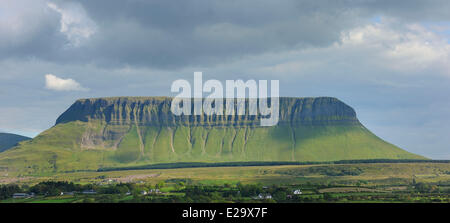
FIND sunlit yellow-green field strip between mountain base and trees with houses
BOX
[0,163,450,185]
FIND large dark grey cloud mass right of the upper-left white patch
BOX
[72,1,366,68]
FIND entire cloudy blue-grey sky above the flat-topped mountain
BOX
[0,0,450,159]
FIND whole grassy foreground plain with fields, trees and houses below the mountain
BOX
[0,163,450,203]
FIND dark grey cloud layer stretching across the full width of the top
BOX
[0,0,450,69]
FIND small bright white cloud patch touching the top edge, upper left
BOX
[47,2,97,47]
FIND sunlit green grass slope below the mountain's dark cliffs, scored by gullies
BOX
[0,121,424,174]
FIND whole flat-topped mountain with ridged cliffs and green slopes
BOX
[0,97,424,173]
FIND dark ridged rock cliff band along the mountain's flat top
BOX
[56,97,359,126]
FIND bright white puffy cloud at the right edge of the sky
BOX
[338,23,450,75]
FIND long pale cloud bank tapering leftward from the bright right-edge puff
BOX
[250,19,450,80]
